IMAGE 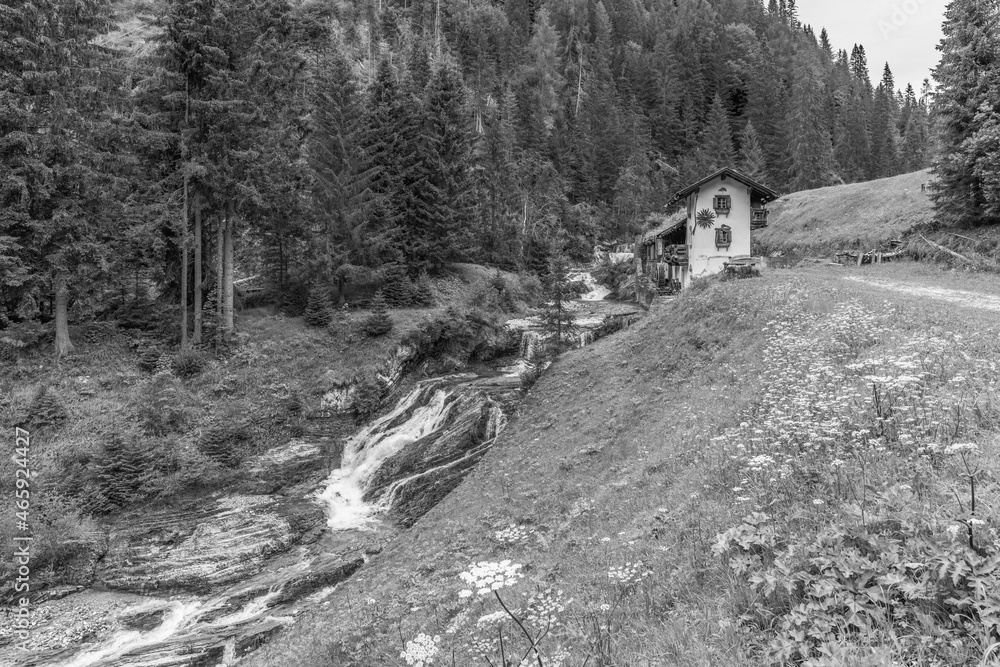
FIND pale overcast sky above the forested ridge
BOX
[798,0,948,95]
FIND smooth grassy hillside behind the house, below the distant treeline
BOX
[754,170,933,255]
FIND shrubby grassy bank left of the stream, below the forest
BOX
[0,266,531,594]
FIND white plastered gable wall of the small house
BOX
[684,177,752,287]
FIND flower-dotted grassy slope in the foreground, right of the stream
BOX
[250,266,1000,667]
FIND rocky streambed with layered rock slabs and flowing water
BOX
[0,295,638,667]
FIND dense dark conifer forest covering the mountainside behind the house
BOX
[0,0,940,354]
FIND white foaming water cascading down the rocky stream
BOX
[21,274,640,667]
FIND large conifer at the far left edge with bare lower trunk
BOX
[0,0,125,355]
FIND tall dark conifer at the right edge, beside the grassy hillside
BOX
[932,0,1000,224]
